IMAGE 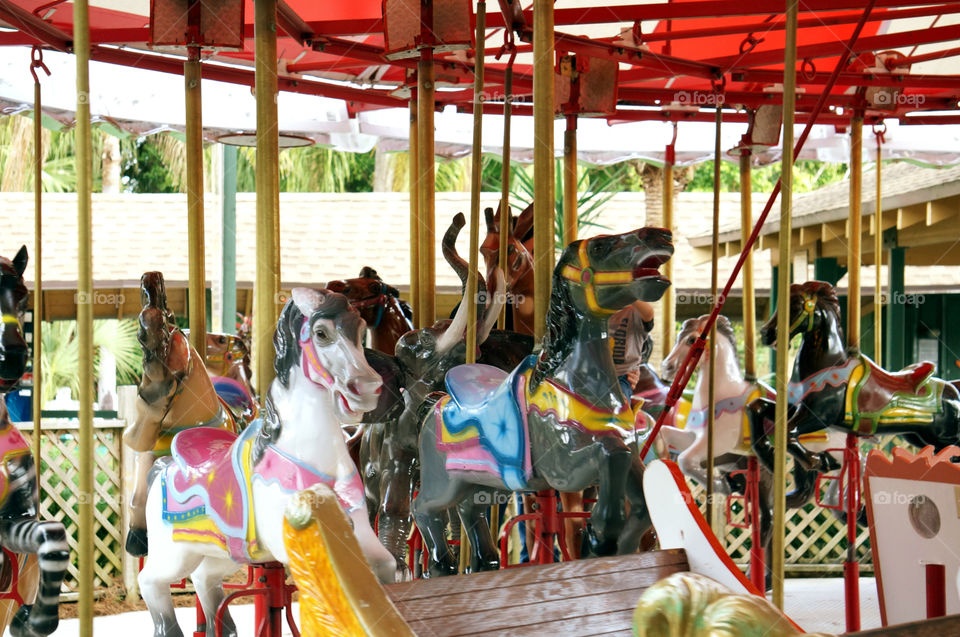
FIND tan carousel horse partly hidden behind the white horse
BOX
[123,272,239,557]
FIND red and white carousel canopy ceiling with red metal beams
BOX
[0,0,960,164]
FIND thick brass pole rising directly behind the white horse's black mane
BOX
[253,0,280,396]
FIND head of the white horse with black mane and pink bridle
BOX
[273,288,382,423]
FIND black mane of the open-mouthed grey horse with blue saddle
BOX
[530,241,583,390]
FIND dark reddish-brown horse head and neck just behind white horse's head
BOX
[327,267,413,356]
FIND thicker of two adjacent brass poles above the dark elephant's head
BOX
[417,47,437,326]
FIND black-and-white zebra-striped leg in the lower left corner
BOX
[0,519,70,637]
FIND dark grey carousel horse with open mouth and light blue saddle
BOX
[413,228,673,575]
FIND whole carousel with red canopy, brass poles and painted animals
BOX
[0,0,960,637]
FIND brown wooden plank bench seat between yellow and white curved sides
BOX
[385,549,689,637]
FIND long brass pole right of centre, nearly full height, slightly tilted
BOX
[770,0,798,610]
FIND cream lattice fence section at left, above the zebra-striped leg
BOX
[18,420,123,591]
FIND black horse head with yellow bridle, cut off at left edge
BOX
[0,246,27,393]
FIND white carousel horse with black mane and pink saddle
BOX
[139,288,397,637]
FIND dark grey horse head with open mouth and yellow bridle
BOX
[554,228,673,319]
